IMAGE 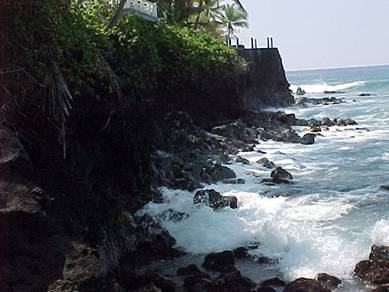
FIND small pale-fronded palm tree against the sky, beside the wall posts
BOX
[216,4,248,41]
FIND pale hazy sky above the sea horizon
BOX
[238,0,389,70]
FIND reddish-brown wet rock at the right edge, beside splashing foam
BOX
[354,245,389,284]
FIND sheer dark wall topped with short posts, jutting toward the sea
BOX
[238,48,294,112]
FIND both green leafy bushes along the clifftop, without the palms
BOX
[15,0,243,95]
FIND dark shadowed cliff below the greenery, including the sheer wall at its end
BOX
[0,41,293,292]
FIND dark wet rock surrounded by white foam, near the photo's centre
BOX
[193,189,238,209]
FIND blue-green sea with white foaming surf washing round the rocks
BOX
[142,66,389,291]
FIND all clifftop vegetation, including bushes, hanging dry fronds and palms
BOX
[4,0,244,154]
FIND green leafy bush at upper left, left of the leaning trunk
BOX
[33,1,110,85]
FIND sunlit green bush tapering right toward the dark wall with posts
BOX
[109,14,241,90]
